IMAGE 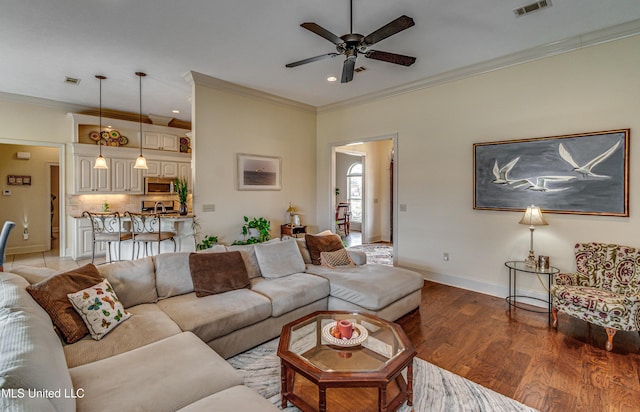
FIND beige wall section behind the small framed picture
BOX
[193,77,317,244]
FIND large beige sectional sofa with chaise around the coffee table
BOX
[0,239,423,412]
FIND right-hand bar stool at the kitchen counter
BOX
[124,212,177,259]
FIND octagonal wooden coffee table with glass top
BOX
[278,311,416,411]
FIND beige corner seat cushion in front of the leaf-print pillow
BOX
[63,303,181,368]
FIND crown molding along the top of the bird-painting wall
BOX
[317,19,640,113]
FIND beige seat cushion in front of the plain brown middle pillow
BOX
[158,289,271,342]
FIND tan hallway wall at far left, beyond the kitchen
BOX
[0,144,58,254]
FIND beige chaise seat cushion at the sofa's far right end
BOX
[307,263,424,311]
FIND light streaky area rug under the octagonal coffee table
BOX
[228,339,535,412]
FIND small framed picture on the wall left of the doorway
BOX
[237,153,282,190]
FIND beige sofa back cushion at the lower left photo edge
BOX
[0,273,75,411]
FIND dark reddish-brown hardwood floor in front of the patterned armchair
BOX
[397,282,640,411]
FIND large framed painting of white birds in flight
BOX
[473,129,630,216]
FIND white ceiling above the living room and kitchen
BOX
[0,0,640,121]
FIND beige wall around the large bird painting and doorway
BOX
[317,36,640,296]
